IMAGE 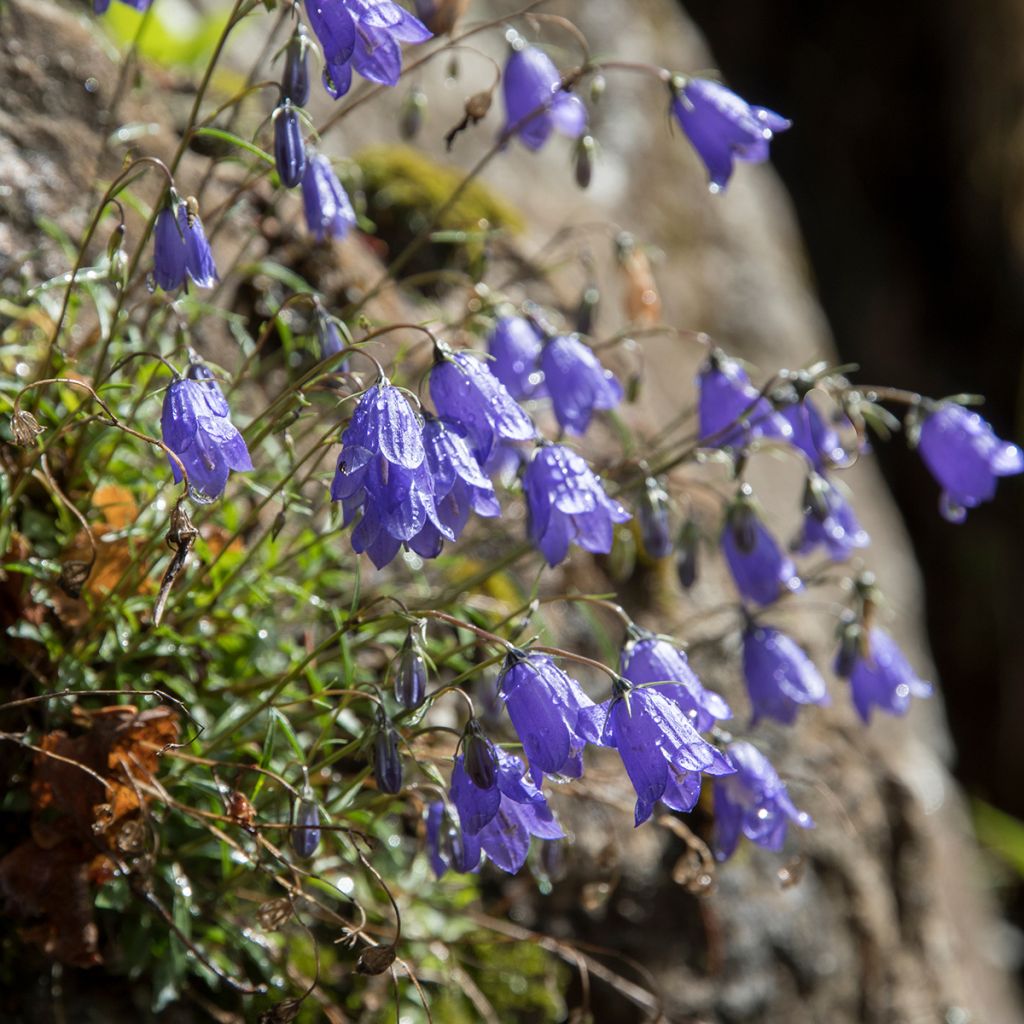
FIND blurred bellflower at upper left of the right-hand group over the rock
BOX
[697,349,793,449]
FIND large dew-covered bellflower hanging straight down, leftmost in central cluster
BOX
[331,380,455,568]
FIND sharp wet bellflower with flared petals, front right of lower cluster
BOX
[581,678,735,825]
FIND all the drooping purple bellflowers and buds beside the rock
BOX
[74,0,1024,877]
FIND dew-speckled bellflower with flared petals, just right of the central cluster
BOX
[522,444,630,565]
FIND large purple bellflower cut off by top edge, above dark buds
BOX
[305,0,431,99]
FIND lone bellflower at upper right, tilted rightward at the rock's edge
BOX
[672,78,792,193]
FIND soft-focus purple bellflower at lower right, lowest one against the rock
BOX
[715,741,814,860]
